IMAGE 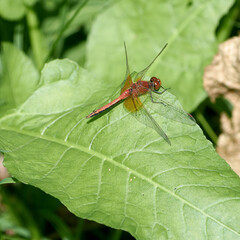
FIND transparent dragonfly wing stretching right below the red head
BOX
[144,92,196,125]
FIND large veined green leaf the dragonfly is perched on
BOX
[0,45,240,240]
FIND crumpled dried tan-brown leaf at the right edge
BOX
[204,37,240,175]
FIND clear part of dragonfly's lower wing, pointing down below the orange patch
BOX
[133,105,171,145]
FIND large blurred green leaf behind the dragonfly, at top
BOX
[87,0,234,111]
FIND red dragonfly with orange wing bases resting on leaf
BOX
[86,43,196,145]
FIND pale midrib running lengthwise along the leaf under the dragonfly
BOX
[0,124,240,236]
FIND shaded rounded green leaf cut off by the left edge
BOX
[0,42,39,116]
